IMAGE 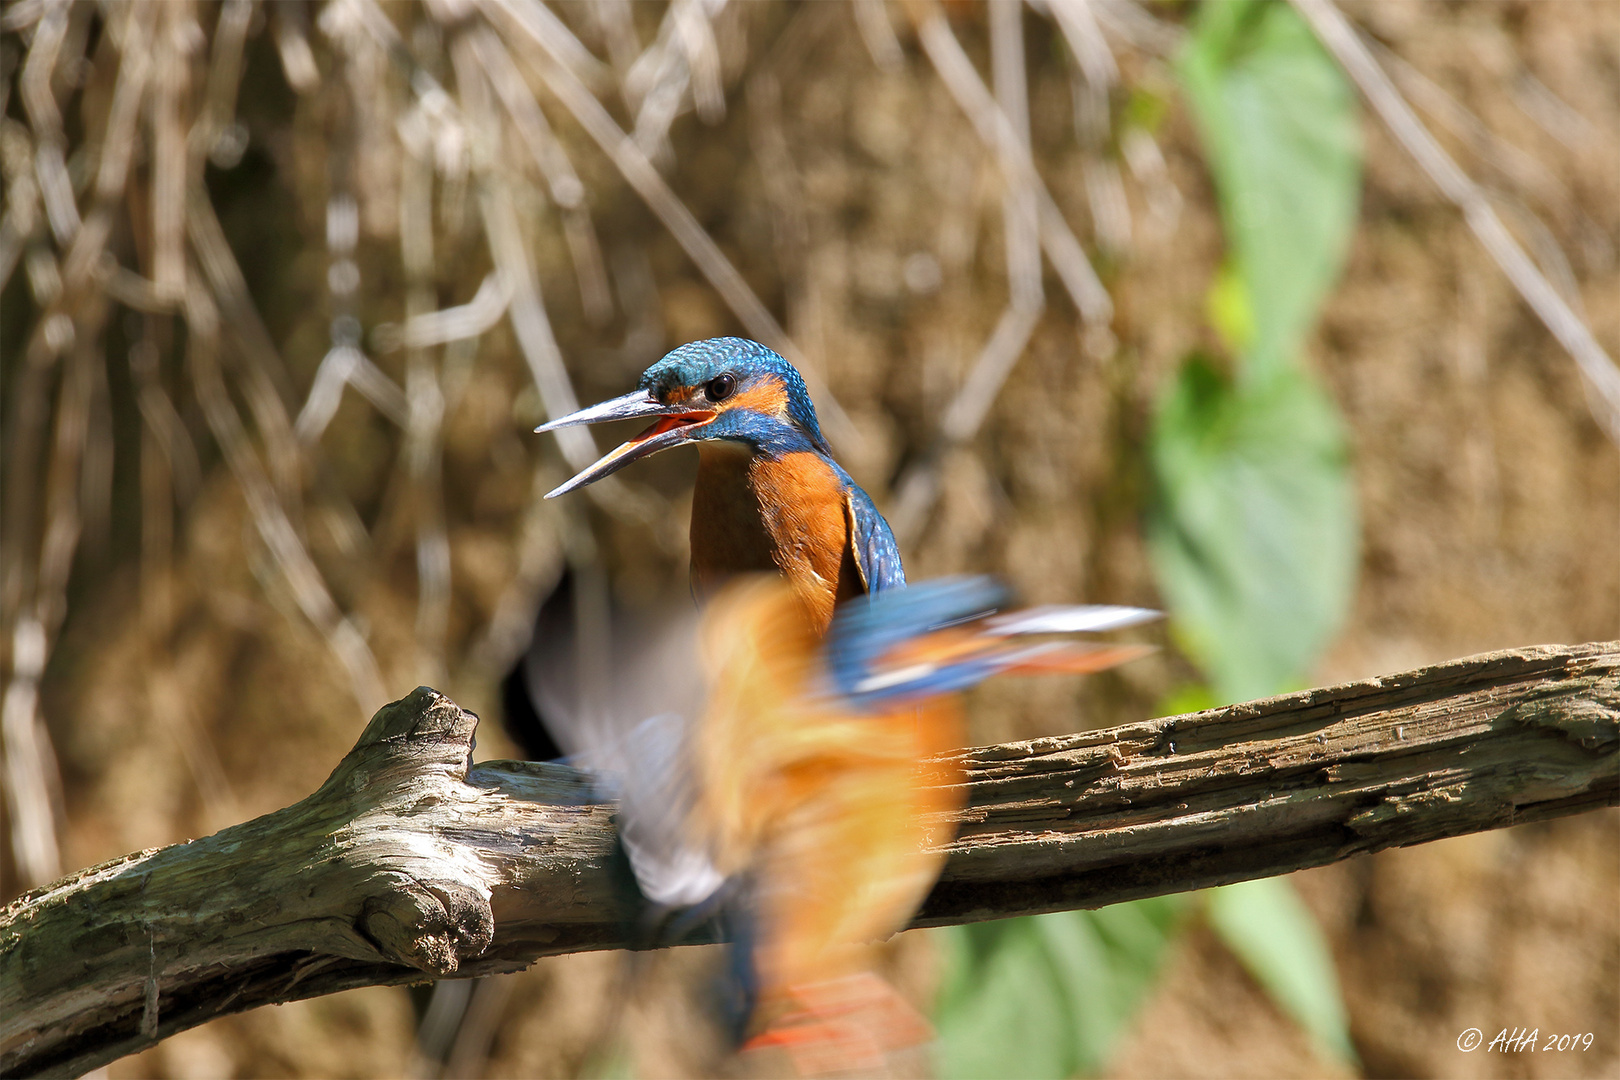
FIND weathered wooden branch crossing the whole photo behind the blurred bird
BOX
[0,641,1620,1077]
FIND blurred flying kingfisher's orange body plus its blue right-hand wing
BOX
[692,576,1153,1074]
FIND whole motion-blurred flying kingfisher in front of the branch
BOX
[509,573,1155,1075]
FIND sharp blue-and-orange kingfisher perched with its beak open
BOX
[535,337,906,633]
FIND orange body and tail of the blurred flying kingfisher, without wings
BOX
[693,576,966,1075]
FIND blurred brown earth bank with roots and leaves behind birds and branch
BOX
[0,0,1620,1077]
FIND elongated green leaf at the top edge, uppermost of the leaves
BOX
[1178,0,1361,377]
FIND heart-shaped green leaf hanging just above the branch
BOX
[1147,356,1358,701]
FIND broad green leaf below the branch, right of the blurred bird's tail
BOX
[935,897,1186,1080]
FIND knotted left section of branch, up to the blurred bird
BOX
[0,687,637,1075]
